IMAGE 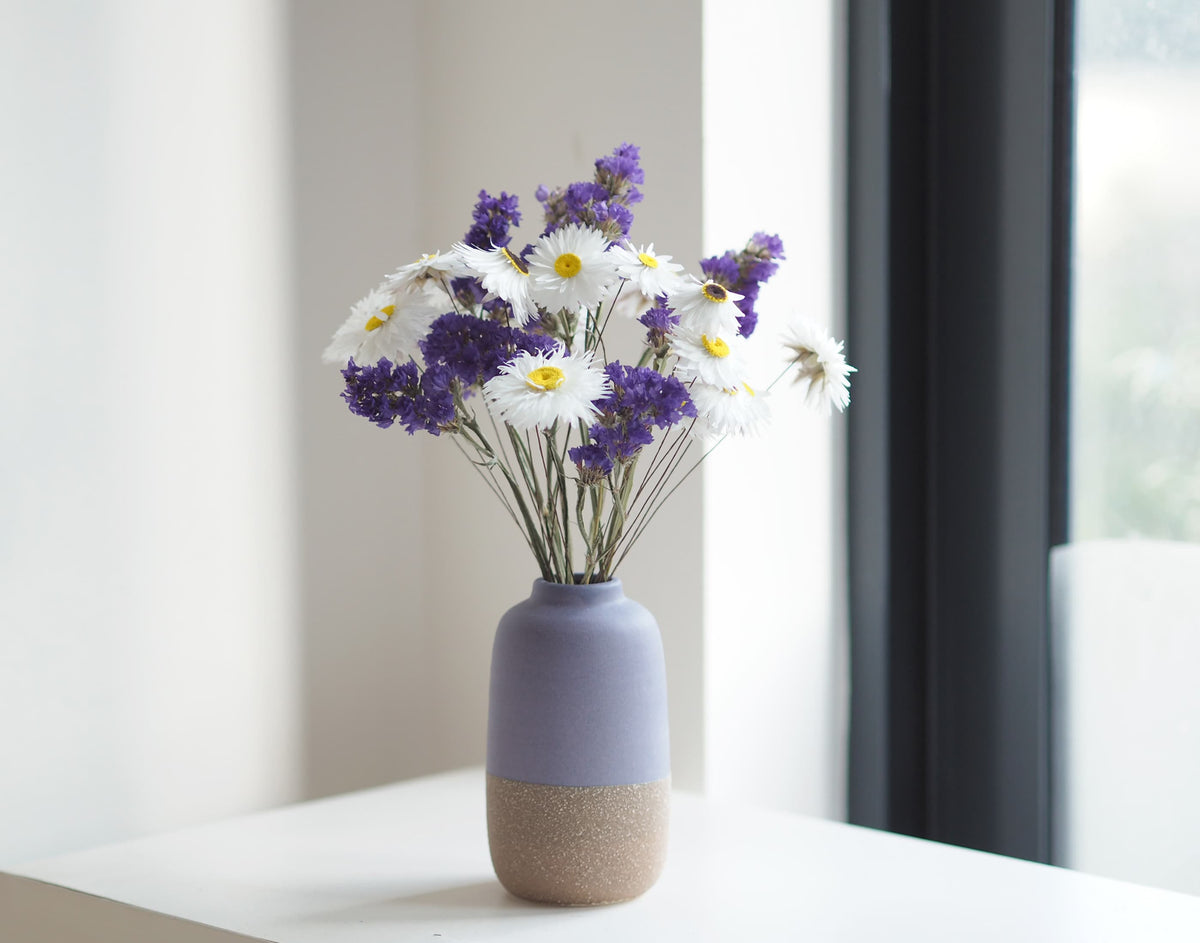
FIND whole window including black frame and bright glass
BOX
[847,0,1200,893]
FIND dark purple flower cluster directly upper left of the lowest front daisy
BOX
[421,312,556,386]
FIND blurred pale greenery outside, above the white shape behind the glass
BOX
[1070,0,1200,542]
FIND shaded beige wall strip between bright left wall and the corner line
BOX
[288,0,438,795]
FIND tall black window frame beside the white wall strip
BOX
[846,0,1074,861]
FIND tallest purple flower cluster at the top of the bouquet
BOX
[535,144,646,241]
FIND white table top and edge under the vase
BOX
[0,770,1200,943]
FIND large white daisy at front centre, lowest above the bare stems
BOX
[484,348,612,430]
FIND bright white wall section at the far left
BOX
[0,0,298,861]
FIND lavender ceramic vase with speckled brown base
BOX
[487,579,671,906]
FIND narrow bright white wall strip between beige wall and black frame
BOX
[703,0,848,817]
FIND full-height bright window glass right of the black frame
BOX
[1051,0,1200,894]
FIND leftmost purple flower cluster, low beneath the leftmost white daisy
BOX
[342,358,455,436]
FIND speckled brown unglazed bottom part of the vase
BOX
[487,775,671,906]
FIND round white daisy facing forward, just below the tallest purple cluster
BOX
[529,223,617,312]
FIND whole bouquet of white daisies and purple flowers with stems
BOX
[324,144,854,583]
